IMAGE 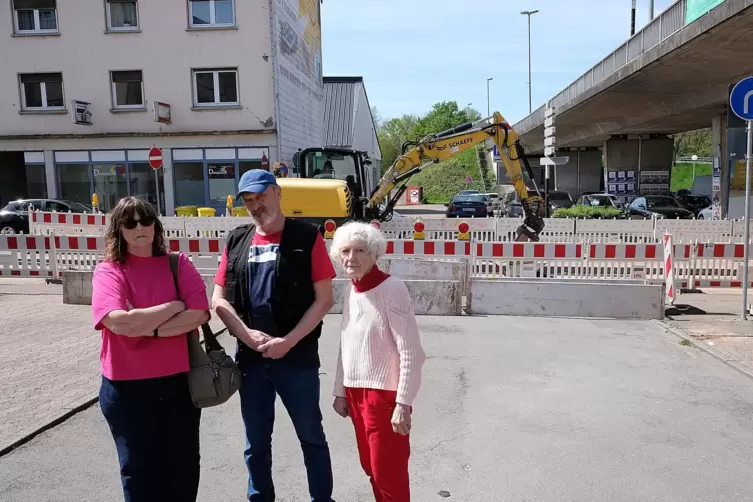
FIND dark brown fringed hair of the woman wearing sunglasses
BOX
[105,197,167,263]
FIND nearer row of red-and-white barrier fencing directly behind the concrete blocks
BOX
[0,235,743,292]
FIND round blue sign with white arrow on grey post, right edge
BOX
[729,77,753,320]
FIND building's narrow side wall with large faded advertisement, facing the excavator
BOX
[270,0,324,171]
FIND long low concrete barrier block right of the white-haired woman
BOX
[468,279,664,319]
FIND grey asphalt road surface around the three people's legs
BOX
[0,315,753,502]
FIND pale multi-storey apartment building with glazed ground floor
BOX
[0,0,323,214]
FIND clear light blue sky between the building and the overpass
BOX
[322,0,673,123]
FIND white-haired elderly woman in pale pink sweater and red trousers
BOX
[330,222,426,502]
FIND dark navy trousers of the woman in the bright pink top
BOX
[99,374,201,502]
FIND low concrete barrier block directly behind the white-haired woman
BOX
[330,279,463,316]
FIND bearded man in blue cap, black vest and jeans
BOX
[212,169,336,502]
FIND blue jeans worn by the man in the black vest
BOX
[239,360,334,502]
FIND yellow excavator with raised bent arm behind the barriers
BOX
[278,112,544,241]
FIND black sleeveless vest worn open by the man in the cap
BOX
[220,218,323,367]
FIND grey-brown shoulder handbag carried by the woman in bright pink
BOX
[169,253,241,408]
